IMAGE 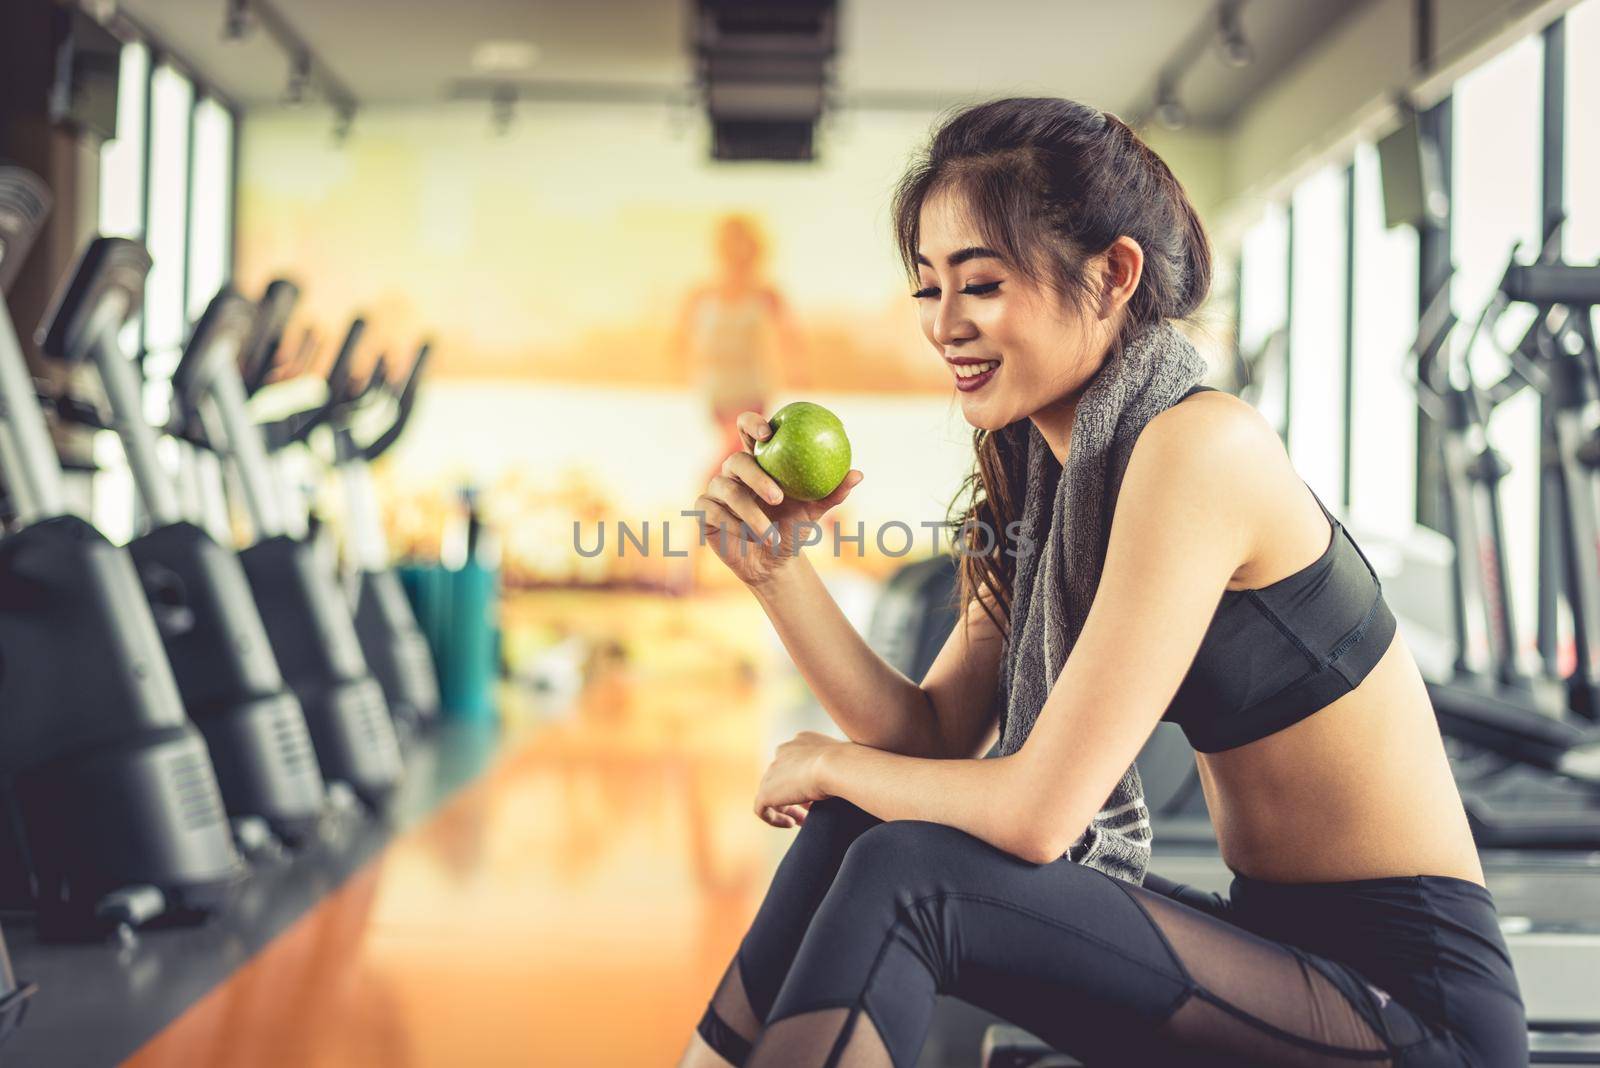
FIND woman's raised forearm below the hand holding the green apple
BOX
[750,556,942,758]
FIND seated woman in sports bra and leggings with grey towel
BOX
[682,99,1526,1068]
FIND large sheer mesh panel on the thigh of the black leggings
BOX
[1130,889,1390,1068]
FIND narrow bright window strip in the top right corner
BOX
[1562,0,1600,264]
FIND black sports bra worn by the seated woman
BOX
[1162,385,1395,753]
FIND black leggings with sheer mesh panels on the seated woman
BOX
[698,798,1528,1068]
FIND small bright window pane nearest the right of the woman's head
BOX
[1238,205,1290,435]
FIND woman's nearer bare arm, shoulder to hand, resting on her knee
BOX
[816,396,1286,863]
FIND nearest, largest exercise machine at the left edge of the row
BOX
[0,166,245,937]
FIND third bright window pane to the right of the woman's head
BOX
[1344,144,1418,536]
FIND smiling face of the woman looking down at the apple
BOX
[915,193,1110,430]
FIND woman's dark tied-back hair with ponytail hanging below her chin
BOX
[893,96,1211,630]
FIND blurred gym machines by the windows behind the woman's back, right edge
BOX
[1397,222,1600,851]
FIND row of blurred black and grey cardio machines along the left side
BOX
[0,165,440,1033]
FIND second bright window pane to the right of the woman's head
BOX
[1288,166,1346,502]
